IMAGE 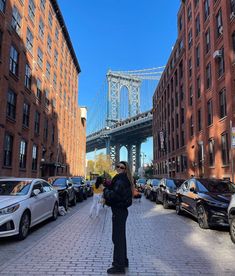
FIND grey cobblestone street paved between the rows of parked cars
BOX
[0,198,235,276]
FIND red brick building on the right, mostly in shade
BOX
[153,0,235,179]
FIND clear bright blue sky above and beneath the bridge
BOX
[58,0,180,164]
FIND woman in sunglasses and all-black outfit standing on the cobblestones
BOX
[104,161,133,274]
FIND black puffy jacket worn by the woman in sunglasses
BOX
[104,173,132,208]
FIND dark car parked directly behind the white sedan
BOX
[49,176,77,211]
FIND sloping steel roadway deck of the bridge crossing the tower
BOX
[86,110,153,152]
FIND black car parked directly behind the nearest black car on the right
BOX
[156,178,184,209]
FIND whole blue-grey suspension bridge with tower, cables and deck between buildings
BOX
[86,66,164,172]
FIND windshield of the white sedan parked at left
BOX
[0,180,31,196]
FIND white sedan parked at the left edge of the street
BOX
[0,178,59,240]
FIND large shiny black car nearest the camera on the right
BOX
[176,178,235,229]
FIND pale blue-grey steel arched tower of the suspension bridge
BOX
[106,71,142,172]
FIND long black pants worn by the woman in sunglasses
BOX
[112,208,128,267]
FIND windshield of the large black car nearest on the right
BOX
[197,179,235,193]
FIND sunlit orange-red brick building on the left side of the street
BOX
[0,0,86,177]
